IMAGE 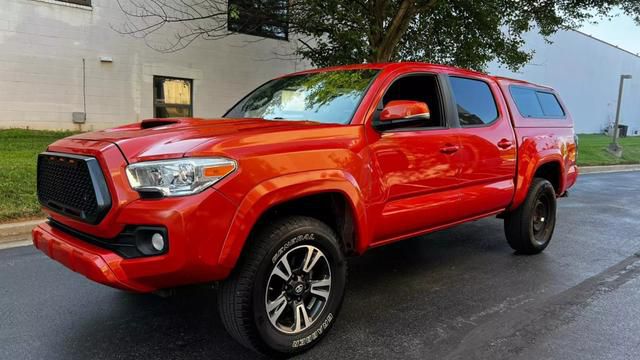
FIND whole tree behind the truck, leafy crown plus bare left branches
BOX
[117,0,640,70]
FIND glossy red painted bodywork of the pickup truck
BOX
[33,63,578,292]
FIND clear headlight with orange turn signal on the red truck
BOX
[127,157,236,196]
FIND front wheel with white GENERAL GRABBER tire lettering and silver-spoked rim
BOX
[218,216,347,356]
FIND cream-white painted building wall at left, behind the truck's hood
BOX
[0,0,306,130]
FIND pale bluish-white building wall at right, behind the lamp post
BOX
[489,31,640,135]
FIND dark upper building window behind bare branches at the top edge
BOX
[227,0,289,40]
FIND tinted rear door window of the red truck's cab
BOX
[450,77,498,126]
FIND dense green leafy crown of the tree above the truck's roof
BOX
[291,0,640,70]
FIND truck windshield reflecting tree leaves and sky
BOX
[225,69,378,124]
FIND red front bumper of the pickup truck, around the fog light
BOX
[32,189,236,292]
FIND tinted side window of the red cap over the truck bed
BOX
[509,86,565,119]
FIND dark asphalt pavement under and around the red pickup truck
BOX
[0,172,640,360]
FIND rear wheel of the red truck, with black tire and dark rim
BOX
[504,178,556,255]
